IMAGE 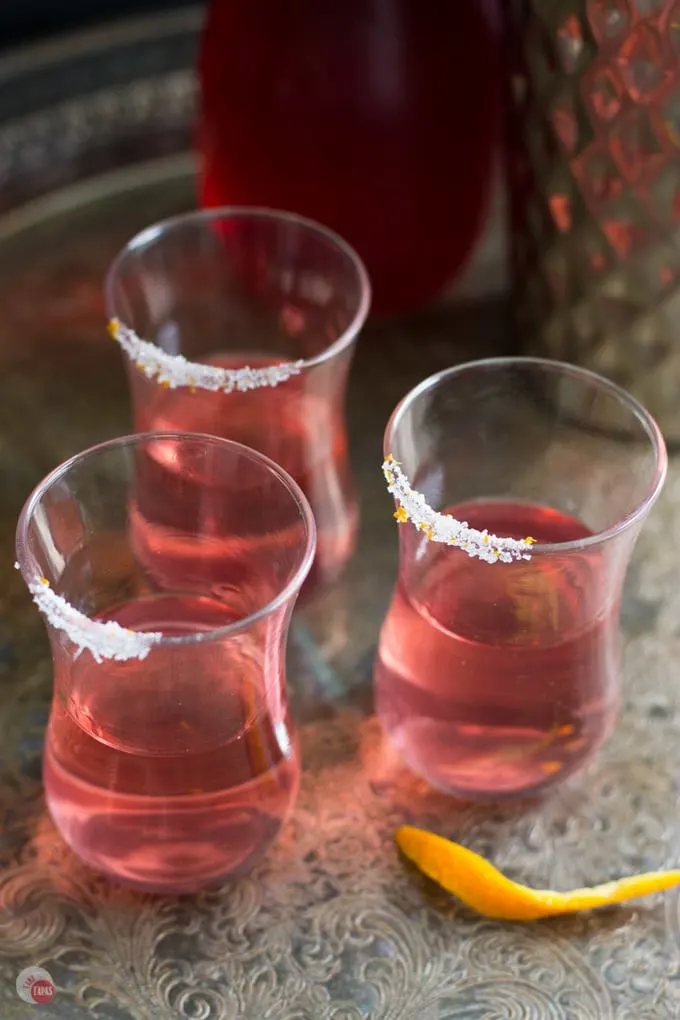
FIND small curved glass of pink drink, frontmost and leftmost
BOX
[16,432,315,893]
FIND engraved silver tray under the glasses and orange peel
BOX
[0,10,680,1020]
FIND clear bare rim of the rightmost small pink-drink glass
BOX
[383,356,668,557]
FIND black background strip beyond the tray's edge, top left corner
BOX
[0,0,196,49]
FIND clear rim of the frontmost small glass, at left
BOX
[15,430,316,648]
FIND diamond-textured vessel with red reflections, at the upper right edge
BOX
[502,0,680,444]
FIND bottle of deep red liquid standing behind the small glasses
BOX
[198,0,500,314]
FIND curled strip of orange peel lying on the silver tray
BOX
[396,825,680,921]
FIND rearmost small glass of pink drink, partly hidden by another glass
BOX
[107,209,370,592]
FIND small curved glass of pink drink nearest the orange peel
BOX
[375,358,667,800]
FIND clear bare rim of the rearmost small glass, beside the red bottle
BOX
[104,205,371,371]
